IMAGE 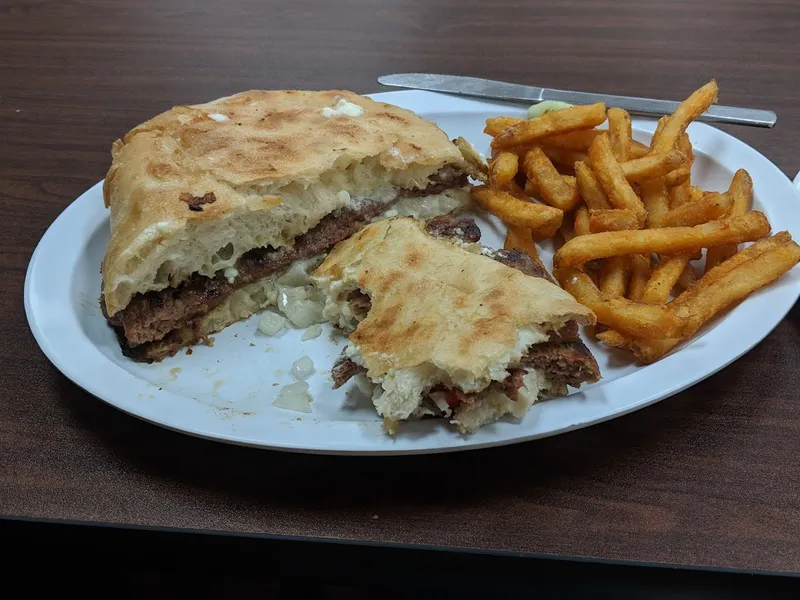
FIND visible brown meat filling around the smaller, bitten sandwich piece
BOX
[331,216,600,408]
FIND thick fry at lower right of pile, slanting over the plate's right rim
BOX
[632,232,800,364]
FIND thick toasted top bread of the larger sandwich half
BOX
[102,90,464,316]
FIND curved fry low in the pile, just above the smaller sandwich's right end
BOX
[556,266,691,339]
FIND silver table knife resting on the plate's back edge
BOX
[378,73,778,127]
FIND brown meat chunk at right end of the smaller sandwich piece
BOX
[520,340,600,387]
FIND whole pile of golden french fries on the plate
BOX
[472,81,800,364]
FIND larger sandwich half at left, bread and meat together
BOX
[101,90,485,362]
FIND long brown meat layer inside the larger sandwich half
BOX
[105,167,474,362]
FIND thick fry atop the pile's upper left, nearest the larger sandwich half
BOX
[492,102,606,150]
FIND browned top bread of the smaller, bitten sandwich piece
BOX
[312,217,595,396]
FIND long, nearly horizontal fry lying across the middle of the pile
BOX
[553,211,769,268]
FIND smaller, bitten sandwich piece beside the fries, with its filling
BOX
[311,217,600,433]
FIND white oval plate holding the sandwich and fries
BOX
[25,91,800,454]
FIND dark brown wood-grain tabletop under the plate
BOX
[0,0,800,571]
